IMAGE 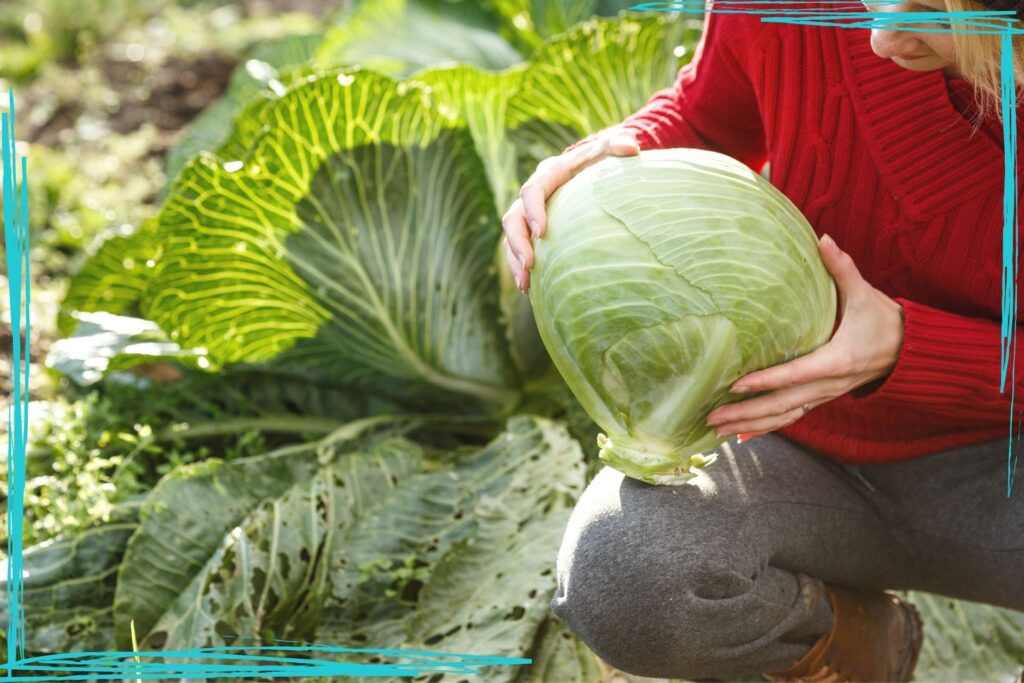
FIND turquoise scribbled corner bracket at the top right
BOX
[629,0,1024,498]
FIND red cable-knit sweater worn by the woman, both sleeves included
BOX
[577,3,1024,463]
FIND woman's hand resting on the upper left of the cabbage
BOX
[502,128,640,294]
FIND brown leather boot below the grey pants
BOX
[762,586,923,683]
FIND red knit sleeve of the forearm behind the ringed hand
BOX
[854,297,1024,426]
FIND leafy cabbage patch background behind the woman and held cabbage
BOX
[0,0,1024,683]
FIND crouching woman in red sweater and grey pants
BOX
[503,0,1024,681]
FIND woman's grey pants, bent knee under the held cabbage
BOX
[552,434,1024,679]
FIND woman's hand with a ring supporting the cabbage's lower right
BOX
[708,236,903,440]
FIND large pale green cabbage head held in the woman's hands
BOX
[530,148,836,484]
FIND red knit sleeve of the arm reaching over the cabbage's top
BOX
[567,7,767,171]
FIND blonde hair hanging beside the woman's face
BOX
[945,0,1024,120]
